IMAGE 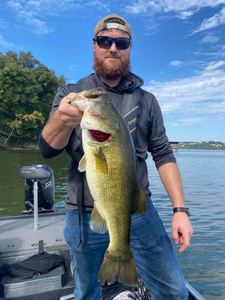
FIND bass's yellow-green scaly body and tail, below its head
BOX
[86,135,138,285]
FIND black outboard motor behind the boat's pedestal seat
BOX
[22,164,55,214]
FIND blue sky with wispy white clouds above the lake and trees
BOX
[0,0,225,142]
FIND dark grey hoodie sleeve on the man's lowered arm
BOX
[148,97,176,169]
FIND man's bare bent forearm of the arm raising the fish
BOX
[42,110,73,149]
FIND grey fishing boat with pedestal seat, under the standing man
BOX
[0,165,204,300]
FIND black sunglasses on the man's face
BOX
[93,36,132,50]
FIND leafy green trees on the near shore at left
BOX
[0,51,66,147]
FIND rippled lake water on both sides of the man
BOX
[0,150,225,300]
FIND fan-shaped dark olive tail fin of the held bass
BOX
[98,249,137,285]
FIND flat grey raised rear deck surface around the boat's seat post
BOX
[0,213,68,258]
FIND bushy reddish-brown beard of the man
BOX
[93,52,131,80]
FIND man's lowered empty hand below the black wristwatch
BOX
[171,212,193,252]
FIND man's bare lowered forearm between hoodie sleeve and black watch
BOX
[158,163,185,207]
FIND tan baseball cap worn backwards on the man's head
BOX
[94,14,132,38]
